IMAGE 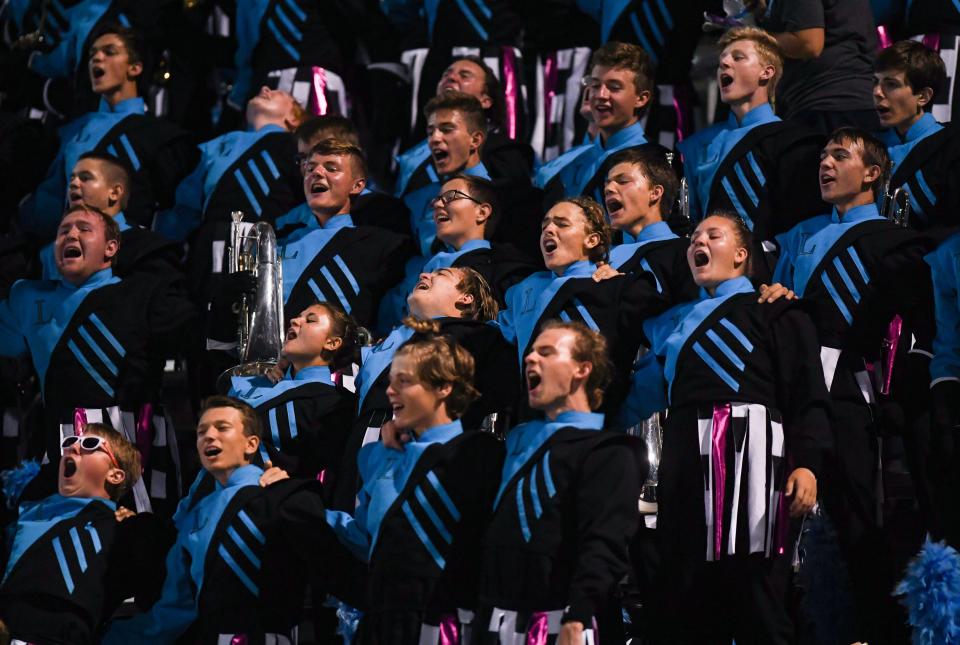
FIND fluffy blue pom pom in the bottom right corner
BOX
[896,538,960,645]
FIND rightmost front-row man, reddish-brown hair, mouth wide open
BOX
[473,321,642,645]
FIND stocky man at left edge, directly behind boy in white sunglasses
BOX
[0,206,194,510]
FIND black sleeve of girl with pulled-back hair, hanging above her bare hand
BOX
[764,302,833,477]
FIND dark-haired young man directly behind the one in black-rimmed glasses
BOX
[403,91,490,257]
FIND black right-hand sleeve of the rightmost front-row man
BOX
[563,444,640,625]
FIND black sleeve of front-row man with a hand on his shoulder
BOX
[279,486,366,607]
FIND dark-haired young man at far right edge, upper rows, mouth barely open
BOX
[873,40,960,237]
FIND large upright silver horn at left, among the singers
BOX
[217,211,284,391]
